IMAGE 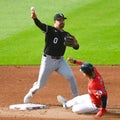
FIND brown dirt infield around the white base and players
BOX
[0,66,120,120]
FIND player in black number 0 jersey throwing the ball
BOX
[24,9,79,103]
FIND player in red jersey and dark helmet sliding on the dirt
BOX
[57,58,107,118]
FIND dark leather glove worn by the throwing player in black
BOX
[64,35,79,49]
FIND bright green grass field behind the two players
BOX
[0,0,120,65]
